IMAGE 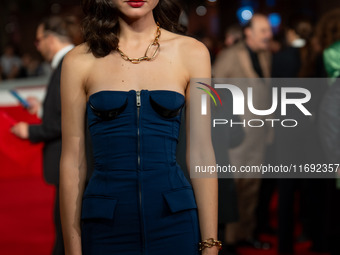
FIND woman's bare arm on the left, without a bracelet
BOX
[59,49,87,255]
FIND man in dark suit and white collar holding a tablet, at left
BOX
[11,17,74,255]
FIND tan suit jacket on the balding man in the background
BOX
[212,41,274,171]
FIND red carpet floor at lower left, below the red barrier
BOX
[0,177,55,255]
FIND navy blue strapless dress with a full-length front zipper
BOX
[81,90,200,255]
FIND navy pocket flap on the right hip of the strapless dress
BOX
[163,187,197,213]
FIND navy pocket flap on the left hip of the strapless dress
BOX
[81,196,118,220]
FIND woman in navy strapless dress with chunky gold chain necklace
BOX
[60,0,220,255]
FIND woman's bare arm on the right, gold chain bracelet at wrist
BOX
[183,40,218,255]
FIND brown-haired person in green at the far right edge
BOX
[316,9,340,255]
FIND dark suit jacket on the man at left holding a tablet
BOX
[29,59,93,185]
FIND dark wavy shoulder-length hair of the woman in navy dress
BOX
[81,0,185,57]
